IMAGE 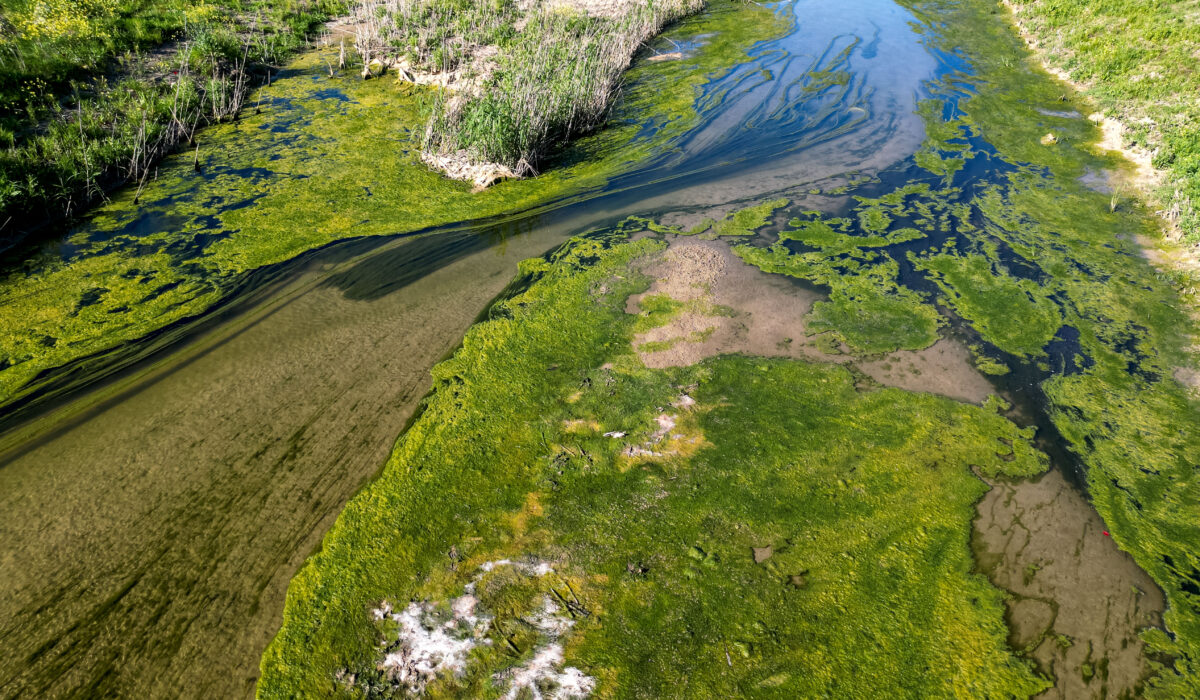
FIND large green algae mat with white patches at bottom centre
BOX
[258,235,1046,698]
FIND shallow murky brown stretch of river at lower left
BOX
[0,224,571,698]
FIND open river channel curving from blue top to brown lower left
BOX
[0,0,1166,698]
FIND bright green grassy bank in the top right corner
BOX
[1010,0,1200,244]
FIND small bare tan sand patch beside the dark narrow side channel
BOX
[858,339,995,403]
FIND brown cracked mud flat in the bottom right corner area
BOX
[973,471,1163,699]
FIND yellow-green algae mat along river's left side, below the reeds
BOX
[0,1,786,415]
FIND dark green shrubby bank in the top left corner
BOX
[0,0,344,241]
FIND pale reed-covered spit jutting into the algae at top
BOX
[354,0,704,184]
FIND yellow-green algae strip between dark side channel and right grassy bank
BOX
[892,2,1200,698]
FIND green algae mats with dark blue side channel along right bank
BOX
[724,1,1200,698]
